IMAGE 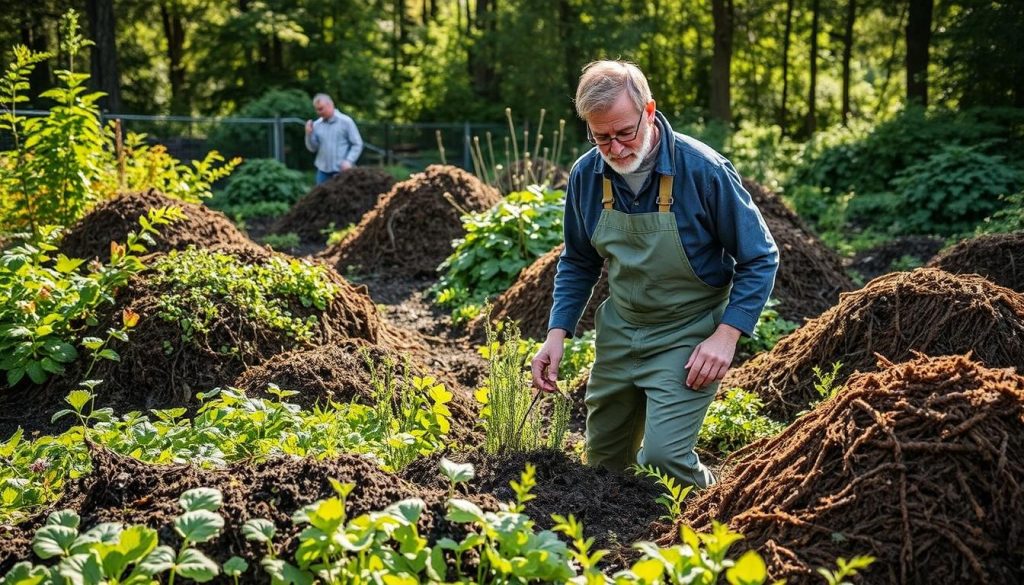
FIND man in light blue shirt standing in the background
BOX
[306,93,362,184]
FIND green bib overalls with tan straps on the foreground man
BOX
[585,162,730,488]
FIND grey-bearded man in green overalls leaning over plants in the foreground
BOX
[531,60,778,488]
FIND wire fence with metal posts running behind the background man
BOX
[0,110,552,171]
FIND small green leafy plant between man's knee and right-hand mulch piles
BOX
[697,388,785,454]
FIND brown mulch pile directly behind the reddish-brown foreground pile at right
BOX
[721,268,1024,420]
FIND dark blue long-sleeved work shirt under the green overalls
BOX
[548,112,778,335]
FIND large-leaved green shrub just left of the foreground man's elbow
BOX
[431,187,565,315]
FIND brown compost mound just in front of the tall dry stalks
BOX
[323,165,501,278]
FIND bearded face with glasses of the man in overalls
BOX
[587,90,654,174]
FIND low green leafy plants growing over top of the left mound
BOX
[150,248,337,343]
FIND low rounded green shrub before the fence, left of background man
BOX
[210,159,309,219]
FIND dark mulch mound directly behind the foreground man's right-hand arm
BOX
[743,179,854,324]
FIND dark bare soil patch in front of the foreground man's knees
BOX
[400,450,665,570]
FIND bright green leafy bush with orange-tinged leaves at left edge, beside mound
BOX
[0,208,184,386]
